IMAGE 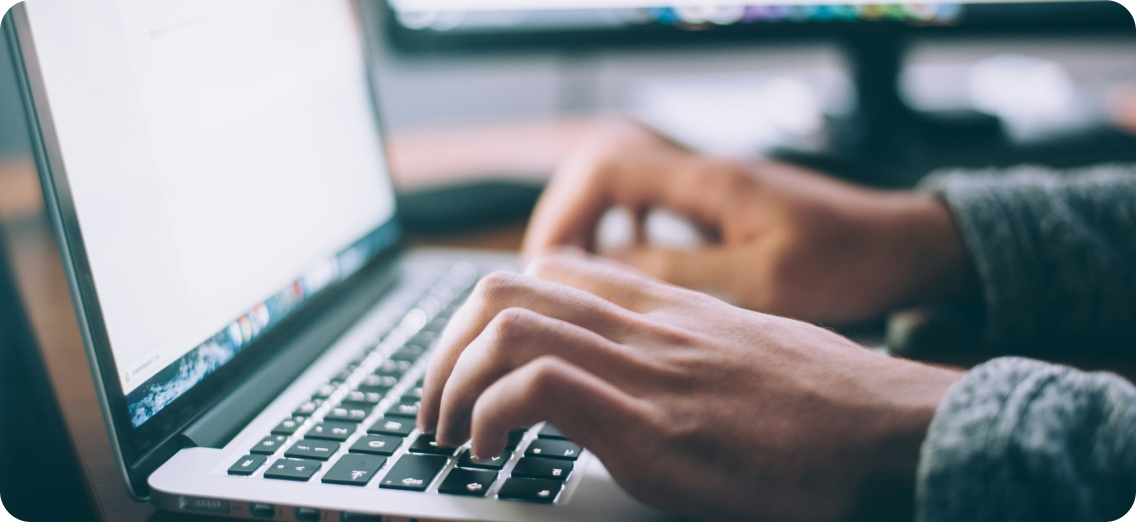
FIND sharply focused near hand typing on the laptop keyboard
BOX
[418,252,960,521]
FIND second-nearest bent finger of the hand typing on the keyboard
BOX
[437,309,638,446]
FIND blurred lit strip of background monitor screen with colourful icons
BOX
[387,0,1130,39]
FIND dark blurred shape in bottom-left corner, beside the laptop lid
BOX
[0,226,93,522]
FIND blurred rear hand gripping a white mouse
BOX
[524,123,975,323]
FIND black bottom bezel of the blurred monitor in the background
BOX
[378,0,1134,54]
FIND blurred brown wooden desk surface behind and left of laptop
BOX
[0,119,590,522]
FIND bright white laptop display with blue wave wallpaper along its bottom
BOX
[25,0,399,428]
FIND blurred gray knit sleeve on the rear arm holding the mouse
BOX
[922,166,1136,354]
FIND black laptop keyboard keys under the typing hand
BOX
[222,263,583,504]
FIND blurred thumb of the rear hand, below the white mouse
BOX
[611,246,736,294]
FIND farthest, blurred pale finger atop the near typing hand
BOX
[525,246,669,313]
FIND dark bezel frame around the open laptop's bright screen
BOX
[5,0,404,499]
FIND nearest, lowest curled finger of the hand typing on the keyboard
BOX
[473,355,649,460]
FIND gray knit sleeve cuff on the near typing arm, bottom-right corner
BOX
[916,357,1136,522]
